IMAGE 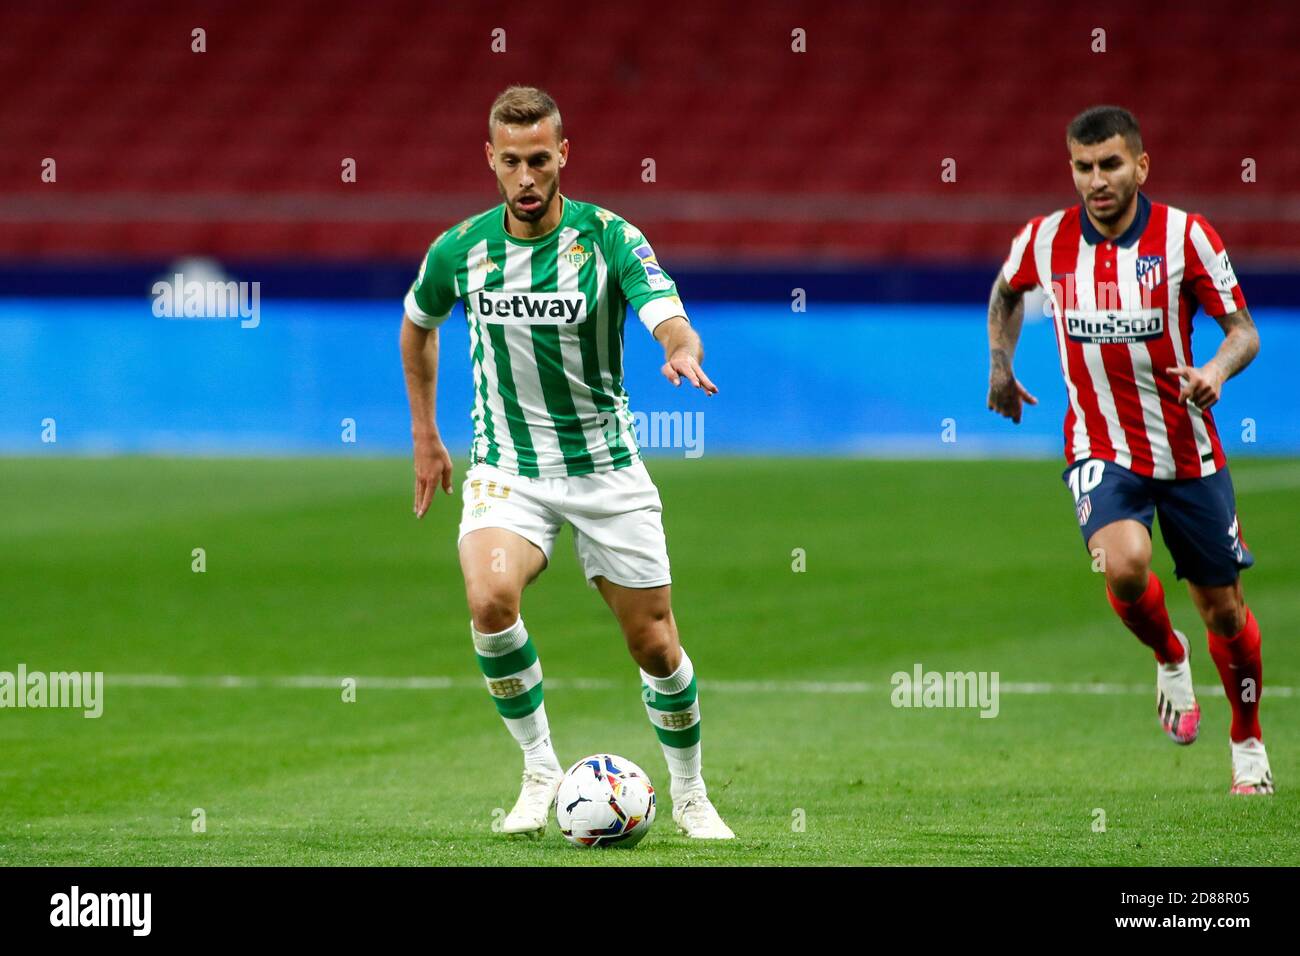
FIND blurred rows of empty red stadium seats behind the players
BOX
[0,0,1300,259]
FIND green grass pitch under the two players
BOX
[0,458,1300,865]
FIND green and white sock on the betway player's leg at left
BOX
[469,617,562,770]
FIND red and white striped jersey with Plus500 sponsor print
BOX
[1002,194,1245,479]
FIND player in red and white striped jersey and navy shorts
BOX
[988,107,1273,793]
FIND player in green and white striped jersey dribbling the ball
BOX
[402,87,735,839]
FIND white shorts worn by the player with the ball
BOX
[456,462,672,588]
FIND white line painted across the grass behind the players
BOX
[105,674,1296,697]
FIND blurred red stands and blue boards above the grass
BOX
[0,0,1300,455]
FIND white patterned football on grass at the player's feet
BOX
[555,753,654,847]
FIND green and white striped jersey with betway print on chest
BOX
[406,196,685,477]
